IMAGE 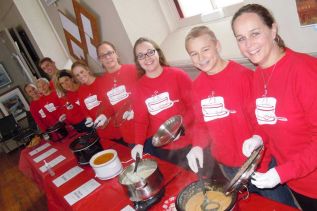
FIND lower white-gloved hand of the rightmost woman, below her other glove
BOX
[251,168,281,188]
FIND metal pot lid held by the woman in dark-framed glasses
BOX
[152,115,183,147]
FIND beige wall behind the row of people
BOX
[0,0,317,67]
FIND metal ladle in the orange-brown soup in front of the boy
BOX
[196,158,220,211]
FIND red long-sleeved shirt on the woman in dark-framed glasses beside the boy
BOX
[133,67,194,149]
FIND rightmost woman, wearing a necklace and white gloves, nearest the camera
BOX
[231,4,317,210]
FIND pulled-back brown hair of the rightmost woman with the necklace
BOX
[231,4,286,50]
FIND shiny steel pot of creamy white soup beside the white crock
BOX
[119,159,163,202]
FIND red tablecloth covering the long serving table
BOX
[20,134,296,211]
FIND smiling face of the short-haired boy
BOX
[186,34,223,75]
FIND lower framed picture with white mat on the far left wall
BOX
[0,87,30,121]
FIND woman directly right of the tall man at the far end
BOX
[55,70,91,133]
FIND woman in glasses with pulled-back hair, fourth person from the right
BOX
[97,41,138,145]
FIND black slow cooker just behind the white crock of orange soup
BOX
[69,133,103,165]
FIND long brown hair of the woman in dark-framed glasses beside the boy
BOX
[133,37,169,76]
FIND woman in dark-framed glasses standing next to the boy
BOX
[131,38,194,167]
